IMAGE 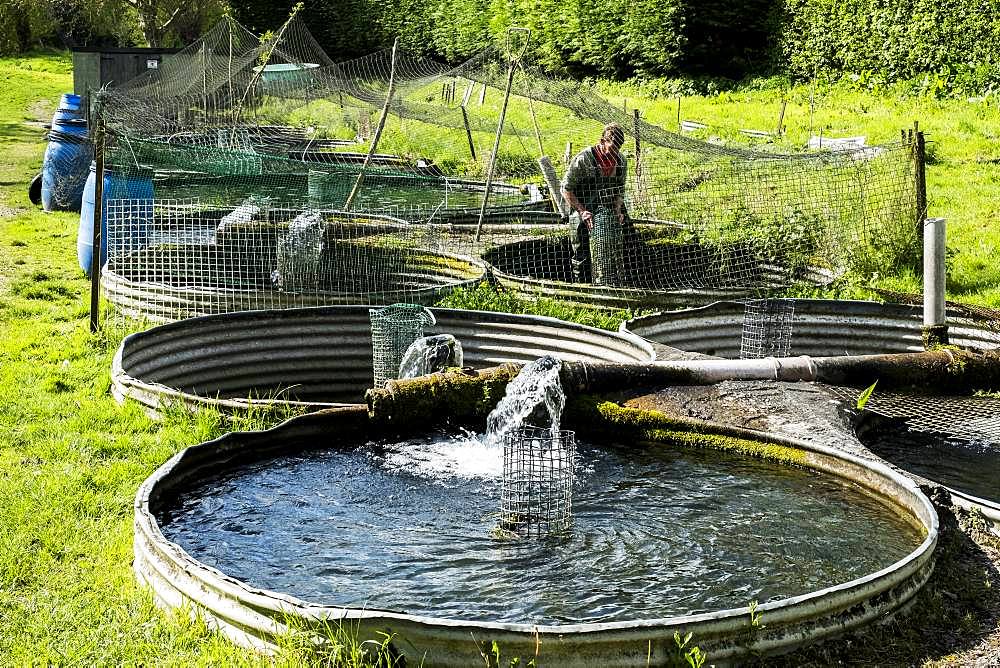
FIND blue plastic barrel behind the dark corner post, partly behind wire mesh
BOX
[76,163,153,276]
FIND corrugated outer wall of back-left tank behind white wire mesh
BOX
[101,250,485,322]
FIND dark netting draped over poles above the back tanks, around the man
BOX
[100,14,917,314]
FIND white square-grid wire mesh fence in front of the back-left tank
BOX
[102,197,484,322]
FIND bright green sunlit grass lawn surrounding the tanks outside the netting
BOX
[0,48,1000,665]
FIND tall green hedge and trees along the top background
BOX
[0,0,1000,97]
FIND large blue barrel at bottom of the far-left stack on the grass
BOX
[42,119,93,211]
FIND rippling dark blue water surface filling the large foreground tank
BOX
[159,434,922,624]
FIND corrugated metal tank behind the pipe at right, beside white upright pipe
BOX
[622,299,1000,359]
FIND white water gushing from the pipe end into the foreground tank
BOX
[486,355,566,449]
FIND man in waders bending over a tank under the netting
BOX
[562,123,632,285]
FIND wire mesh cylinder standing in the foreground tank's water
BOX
[500,427,576,536]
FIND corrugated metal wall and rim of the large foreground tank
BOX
[133,407,939,666]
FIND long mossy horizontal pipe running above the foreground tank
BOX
[365,349,1000,425]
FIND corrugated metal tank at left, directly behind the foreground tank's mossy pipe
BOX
[111,306,654,413]
